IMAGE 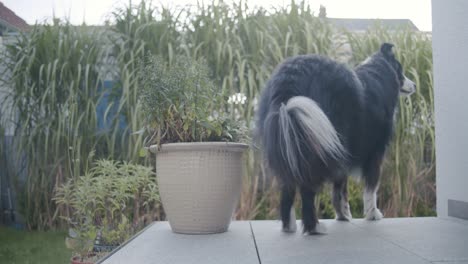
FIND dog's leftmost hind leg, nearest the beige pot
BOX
[280,186,297,233]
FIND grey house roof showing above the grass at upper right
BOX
[327,18,419,31]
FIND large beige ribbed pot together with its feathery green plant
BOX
[139,57,248,234]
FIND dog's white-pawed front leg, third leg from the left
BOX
[333,176,353,221]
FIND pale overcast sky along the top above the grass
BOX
[0,0,432,31]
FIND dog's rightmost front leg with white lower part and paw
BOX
[363,155,383,220]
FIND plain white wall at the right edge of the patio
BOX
[432,0,468,217]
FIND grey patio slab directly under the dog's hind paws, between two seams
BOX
[252,220,430,264]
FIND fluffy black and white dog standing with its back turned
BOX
[256,43,415,234]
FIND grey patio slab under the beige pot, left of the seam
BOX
[101,221,258,264]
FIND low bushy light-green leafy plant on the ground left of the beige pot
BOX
[54,160,159,257]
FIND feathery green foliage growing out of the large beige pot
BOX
[139,56,247,145]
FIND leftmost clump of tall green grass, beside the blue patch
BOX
[2,20,101,229]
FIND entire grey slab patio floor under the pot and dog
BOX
[100,217,468,264]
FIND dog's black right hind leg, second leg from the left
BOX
[301,187,325,235]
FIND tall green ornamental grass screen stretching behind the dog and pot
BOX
[2,1,435,228]
